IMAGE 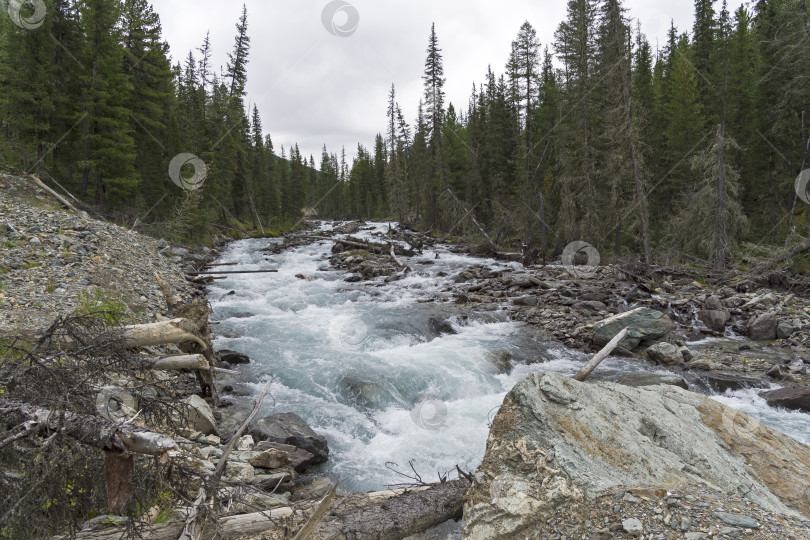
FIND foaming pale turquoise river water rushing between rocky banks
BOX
[208,223,810,491]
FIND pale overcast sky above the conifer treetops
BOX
[154,0,743,165]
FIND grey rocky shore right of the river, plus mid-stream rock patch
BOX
[318,223,810,394]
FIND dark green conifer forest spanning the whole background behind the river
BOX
[0,0,810,266]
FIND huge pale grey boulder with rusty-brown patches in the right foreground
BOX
[462,373,810,540]
